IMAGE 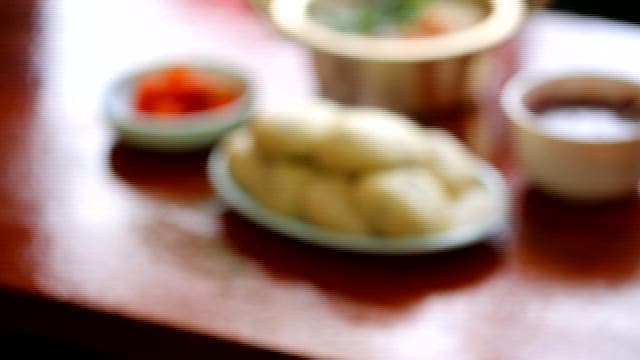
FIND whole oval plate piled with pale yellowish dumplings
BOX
[208,101,508,255]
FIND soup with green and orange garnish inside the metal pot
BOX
[311,0,486,36]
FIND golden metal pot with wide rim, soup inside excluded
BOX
[268,0,527,114]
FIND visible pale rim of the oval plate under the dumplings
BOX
[207,150,508,255]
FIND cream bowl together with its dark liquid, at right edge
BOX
[501,73,640,202]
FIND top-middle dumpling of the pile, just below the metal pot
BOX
[314,108,426,173]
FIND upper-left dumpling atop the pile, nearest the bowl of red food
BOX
[250,102,339,157]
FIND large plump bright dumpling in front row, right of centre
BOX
[354,168,450,236]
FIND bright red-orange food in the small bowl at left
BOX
[134,66,244,121]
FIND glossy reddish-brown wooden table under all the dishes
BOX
[0,0,640,359]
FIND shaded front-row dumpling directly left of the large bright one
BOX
[303,175,368,234]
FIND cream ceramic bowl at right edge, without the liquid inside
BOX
[501,73,640,202]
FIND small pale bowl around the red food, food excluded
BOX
[105,63,253,151]
